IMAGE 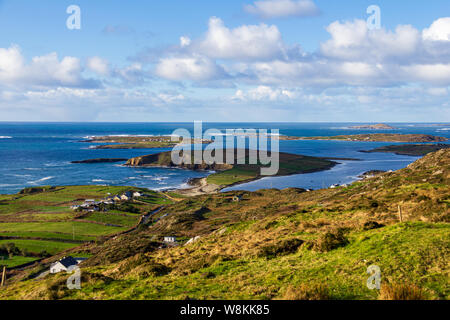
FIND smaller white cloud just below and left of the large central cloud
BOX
[155,55,223,81]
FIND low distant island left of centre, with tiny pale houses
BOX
[81,136,212,149]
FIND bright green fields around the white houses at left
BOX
[0,186,171,267]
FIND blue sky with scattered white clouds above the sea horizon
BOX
[0,0,450,122]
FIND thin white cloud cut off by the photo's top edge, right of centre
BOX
[244,0,319,19]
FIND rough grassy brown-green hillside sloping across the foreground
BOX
[0,149,450,299]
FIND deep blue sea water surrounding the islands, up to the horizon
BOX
[0,122,450,194]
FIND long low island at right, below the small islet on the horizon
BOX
[298,133,448,142]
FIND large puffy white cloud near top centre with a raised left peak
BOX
[191,17,284,59]
